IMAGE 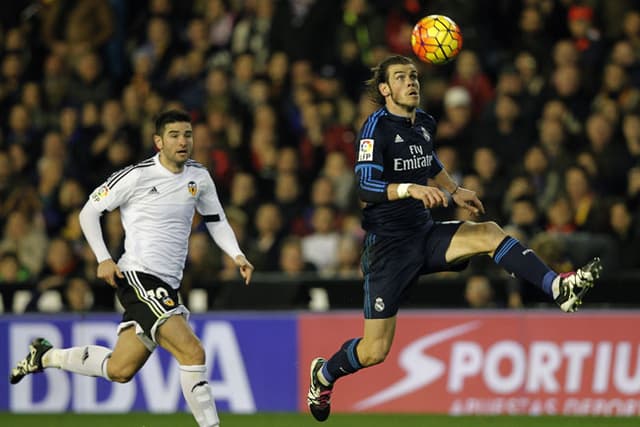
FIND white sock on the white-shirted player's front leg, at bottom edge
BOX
[180,365,220,427]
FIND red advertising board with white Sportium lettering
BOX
[299,311,640,416]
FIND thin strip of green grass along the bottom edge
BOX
[0,413,640,427]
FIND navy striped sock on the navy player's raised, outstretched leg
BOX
[493,236,558,295]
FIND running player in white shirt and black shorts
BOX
[10,110,253,427]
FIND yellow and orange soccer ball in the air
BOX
[411,15,462,65]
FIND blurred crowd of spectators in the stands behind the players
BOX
[0,0,640,311]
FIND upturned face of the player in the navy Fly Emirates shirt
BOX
[380,64,420,114]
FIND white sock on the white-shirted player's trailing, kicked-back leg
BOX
[42,345,111,380]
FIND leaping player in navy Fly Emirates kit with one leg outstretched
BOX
[307,56,602,421]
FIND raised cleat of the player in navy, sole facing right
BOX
[552,257,602,313]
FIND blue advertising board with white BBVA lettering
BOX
[0,313,299,413]
